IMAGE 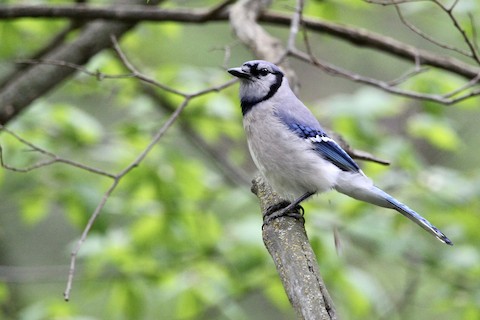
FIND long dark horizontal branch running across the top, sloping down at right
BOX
[0,1,480,80]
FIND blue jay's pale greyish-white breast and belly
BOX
[243,101,341,199]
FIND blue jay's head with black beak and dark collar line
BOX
[228,60,284,114]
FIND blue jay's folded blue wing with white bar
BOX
[279,115,360,172]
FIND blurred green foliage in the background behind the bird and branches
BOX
[0,0,480,320]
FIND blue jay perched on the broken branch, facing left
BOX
[228,60,453,245]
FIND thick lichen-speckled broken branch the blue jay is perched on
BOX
[252,177,337,320]
